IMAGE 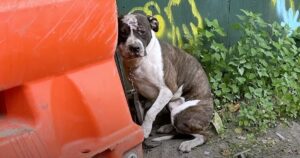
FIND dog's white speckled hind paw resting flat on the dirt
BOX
[178,134,205,152]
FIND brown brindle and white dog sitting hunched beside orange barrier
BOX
[117,13,213,152]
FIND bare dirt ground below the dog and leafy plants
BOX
[144,121,300,158]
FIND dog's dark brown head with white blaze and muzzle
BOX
[118,13,158,59]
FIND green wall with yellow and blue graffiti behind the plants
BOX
[117,0,300,46]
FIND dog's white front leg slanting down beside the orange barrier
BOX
[142,87,173,138]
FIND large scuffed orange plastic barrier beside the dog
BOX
[0,0,143,158]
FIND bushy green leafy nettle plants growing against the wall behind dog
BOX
[184,10,300,130]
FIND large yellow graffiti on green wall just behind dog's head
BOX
[130,0,203,47]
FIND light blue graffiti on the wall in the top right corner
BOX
[272,0,300,31]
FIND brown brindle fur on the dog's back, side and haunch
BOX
[160,41,213,134]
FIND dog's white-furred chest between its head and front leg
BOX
[131,52,165,100]
